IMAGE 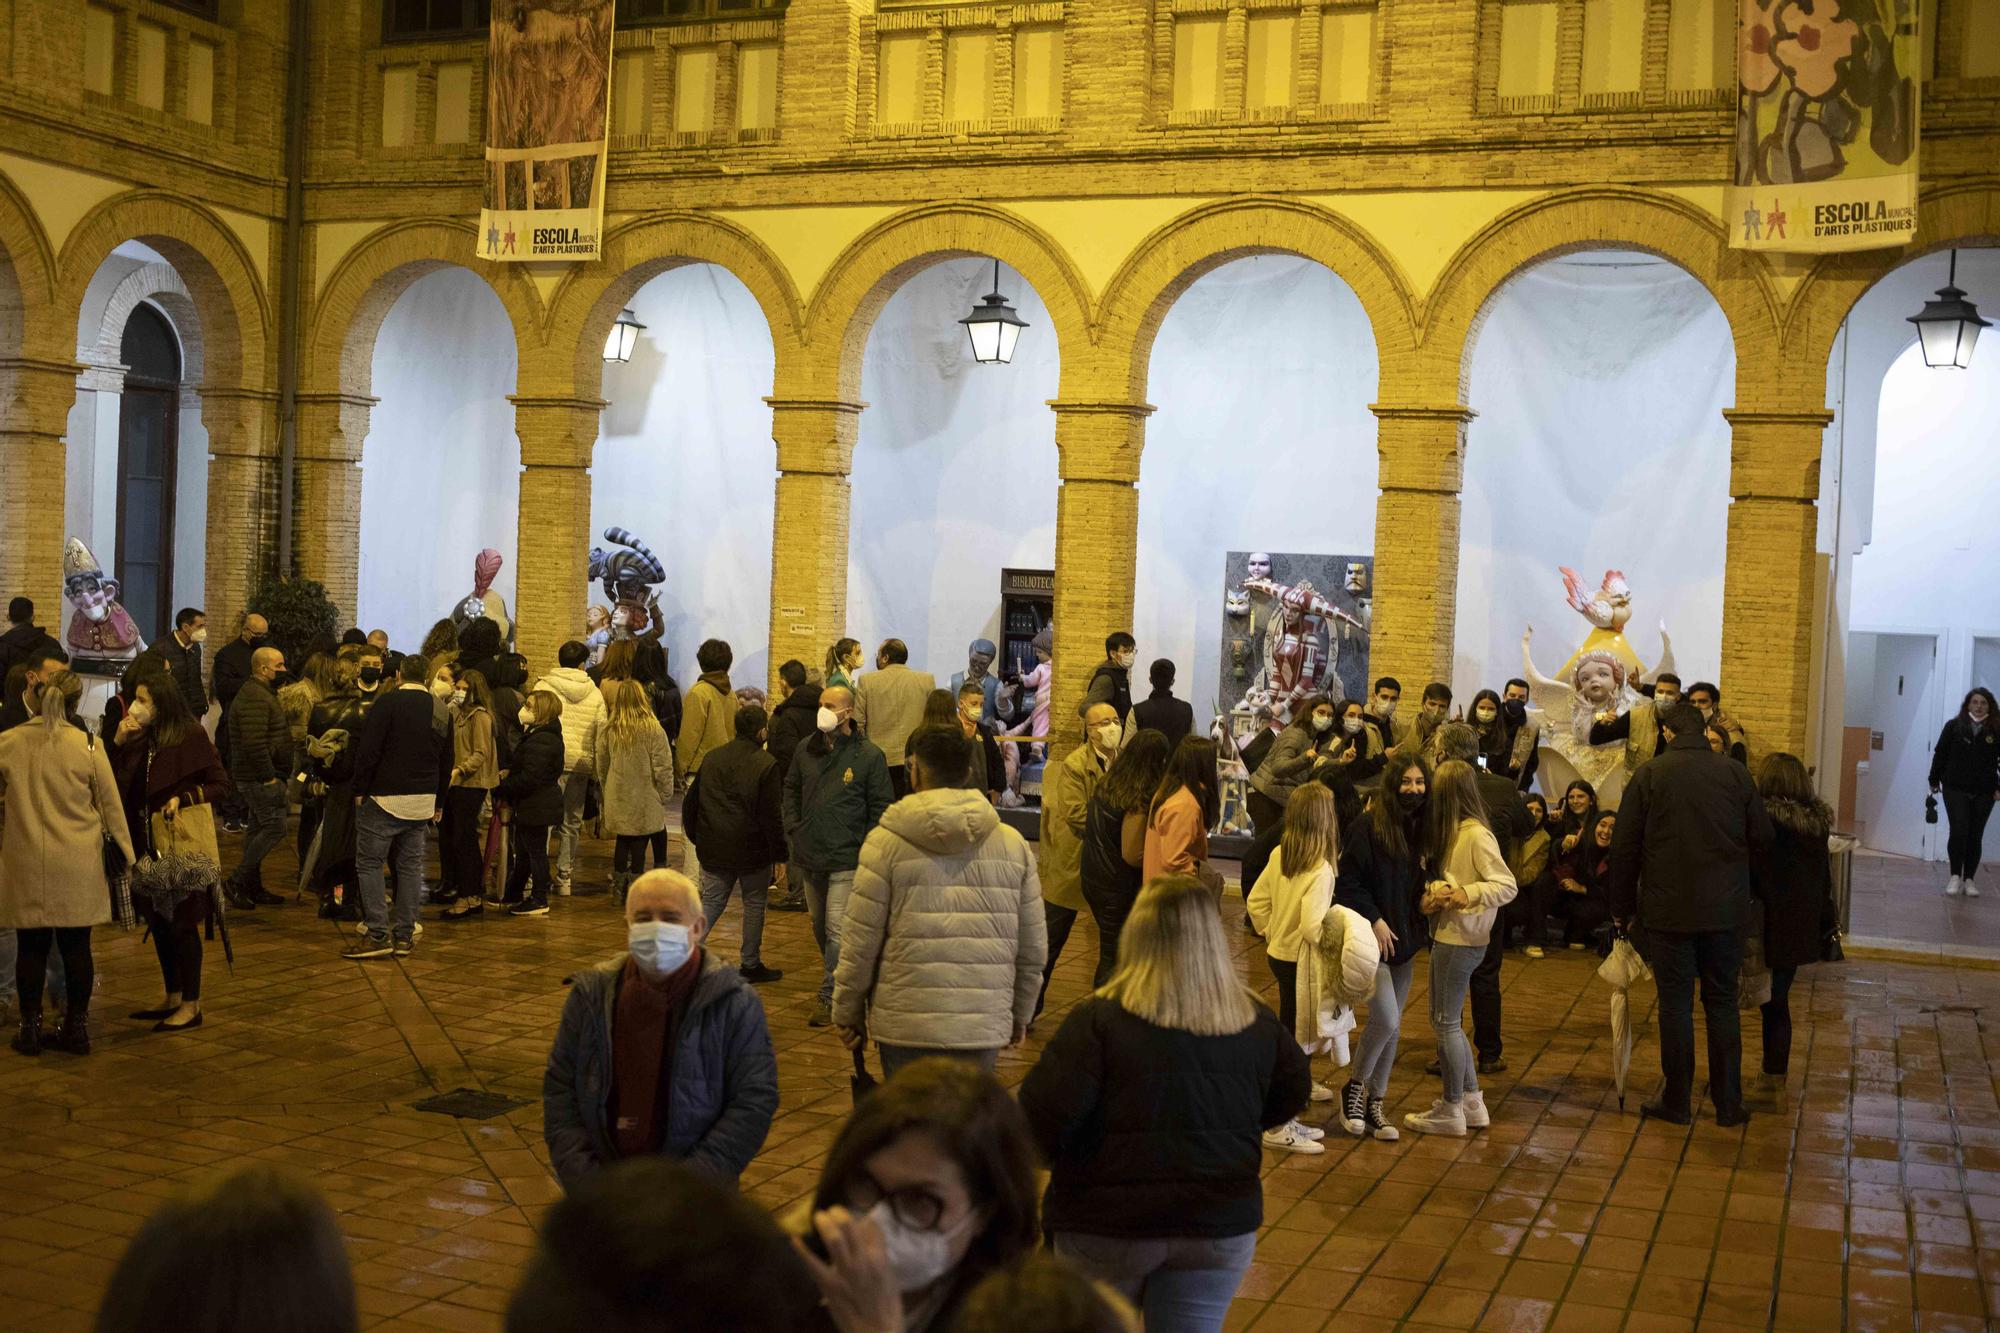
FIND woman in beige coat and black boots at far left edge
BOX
[0,669,132,1055]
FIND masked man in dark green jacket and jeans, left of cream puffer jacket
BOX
[784,685,896,1027]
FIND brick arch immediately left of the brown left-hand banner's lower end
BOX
[300,218,542,396]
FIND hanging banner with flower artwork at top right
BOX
[1724,0,1920,254]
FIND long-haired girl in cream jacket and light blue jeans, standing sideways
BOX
[1402,759,1518,1135]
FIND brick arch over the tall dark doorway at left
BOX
[58,190,278,388]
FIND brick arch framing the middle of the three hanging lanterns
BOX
[806,204,1096,402]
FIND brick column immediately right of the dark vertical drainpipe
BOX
[292,392,380,624]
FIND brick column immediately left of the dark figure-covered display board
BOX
[1048,400,1152,761]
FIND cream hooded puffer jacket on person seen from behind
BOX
[834,789,1048,1051]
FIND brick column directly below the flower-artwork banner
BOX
[1718,408,1834,757]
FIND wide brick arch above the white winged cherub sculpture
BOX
[1420,186,1778,402]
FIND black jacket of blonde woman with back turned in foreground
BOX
[1020,997,1312,1237]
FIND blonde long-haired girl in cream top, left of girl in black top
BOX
[1244,783,1340,1153]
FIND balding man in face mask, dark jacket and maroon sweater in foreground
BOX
[542,871,778,1189]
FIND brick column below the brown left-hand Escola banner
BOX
[508,394,606,677]
